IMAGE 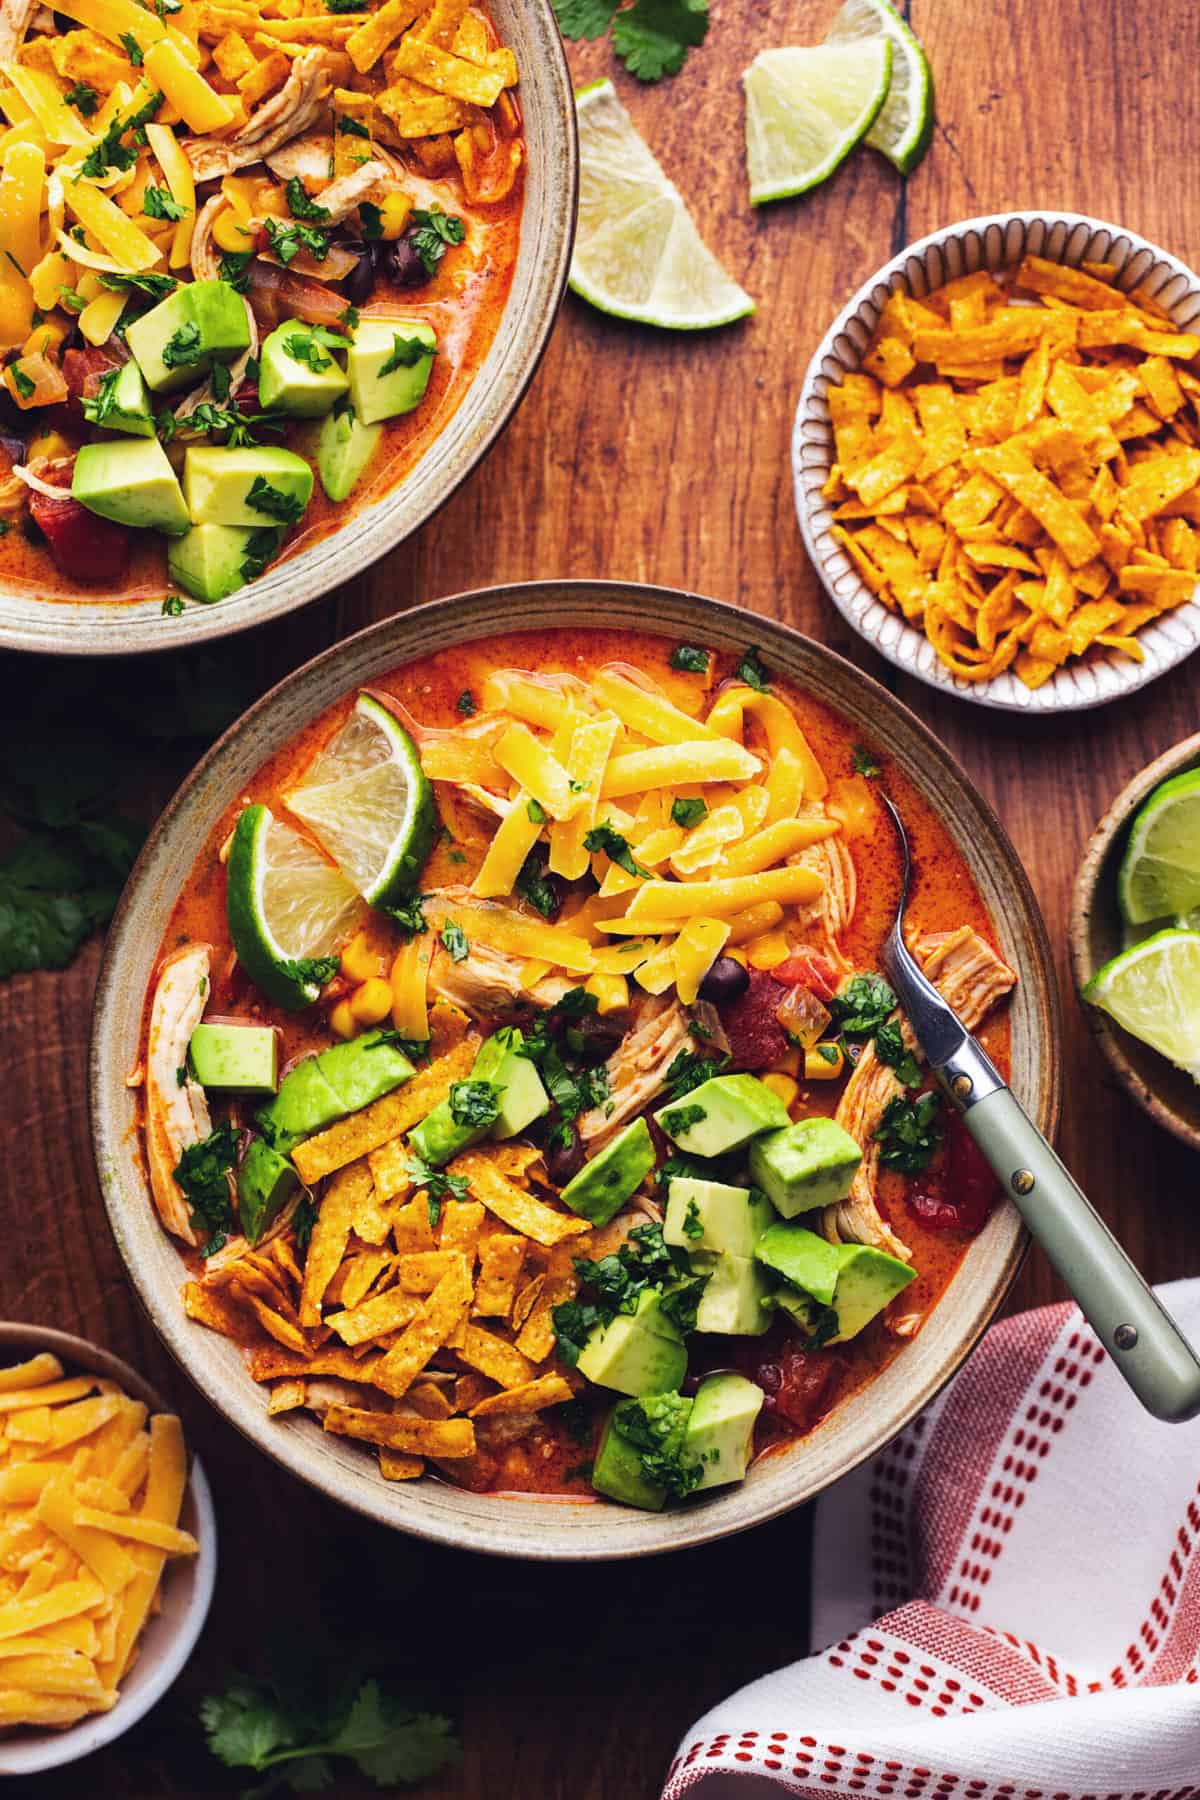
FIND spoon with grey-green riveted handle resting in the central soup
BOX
[880,794,1200,1422]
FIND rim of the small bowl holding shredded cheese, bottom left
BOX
[0,1319,216,1782]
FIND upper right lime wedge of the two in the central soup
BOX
[284,693,437,907]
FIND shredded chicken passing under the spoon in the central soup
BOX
[820,925,1016,1262]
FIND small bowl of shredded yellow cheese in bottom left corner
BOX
[0,1323,216,1778]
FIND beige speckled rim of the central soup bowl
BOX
[90,581,1061,1562]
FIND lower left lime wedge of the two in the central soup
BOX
[225,806,362,1012]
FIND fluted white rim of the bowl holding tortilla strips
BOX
[792,211,1200,716]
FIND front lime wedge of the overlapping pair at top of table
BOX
[741,38,892,207]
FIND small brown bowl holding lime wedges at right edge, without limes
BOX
[1069,731,1200,1150]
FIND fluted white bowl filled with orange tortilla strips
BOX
[792,212,1200,715]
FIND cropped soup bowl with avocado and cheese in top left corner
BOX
[0,0,578,653]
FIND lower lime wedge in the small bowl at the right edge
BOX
[1083,931,1200,1080]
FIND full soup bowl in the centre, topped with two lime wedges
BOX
[92,581,1060,1559]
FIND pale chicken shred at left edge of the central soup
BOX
[146,943,212,1244]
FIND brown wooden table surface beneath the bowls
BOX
[0,0,1200,1800]
